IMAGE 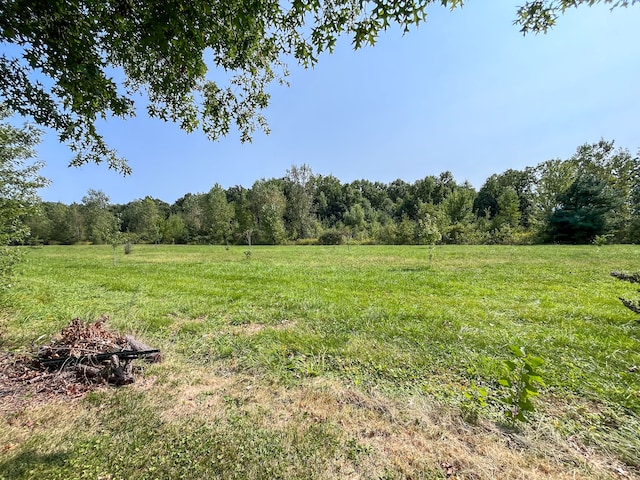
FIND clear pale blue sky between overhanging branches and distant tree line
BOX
[32,0,640,203]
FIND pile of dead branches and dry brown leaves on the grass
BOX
[36,316,161,385]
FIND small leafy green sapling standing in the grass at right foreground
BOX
[498,345,545,423]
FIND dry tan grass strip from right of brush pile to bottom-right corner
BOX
[156,369,639,480]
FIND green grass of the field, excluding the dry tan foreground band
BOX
[0,246,640,478]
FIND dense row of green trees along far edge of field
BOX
[24,140,640,245]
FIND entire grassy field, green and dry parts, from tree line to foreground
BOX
[0,246,640,479]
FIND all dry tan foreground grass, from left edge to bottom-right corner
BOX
[0,361,640,480]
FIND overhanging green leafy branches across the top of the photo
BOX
[0,0,640,173]
